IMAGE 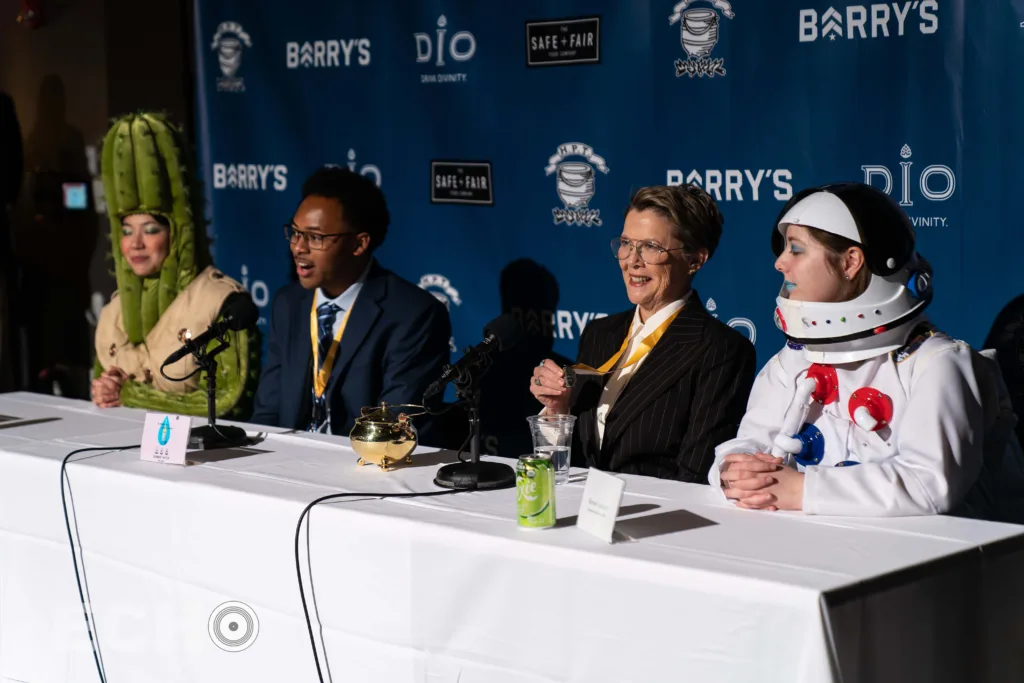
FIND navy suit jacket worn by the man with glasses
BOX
[251,262,452,438]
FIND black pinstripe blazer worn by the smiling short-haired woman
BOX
[571,292,756,483]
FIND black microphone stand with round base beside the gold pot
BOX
[434,354,515,490]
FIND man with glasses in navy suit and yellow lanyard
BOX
[251,167,452,437]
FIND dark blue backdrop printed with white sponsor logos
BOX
[195,0,1024,451]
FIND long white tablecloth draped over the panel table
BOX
[0,393,1024,683]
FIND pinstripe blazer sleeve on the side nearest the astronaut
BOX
[678,336,757,483]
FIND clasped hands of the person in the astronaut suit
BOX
[720,453,804,512]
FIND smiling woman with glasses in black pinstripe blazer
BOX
[530,185,756,483]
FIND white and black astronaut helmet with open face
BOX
[771,182,932,362]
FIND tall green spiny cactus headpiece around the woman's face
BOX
[102,112,209,344]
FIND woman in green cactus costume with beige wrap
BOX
[92,113,259,418]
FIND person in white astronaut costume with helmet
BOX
[708,183,1024,523]
